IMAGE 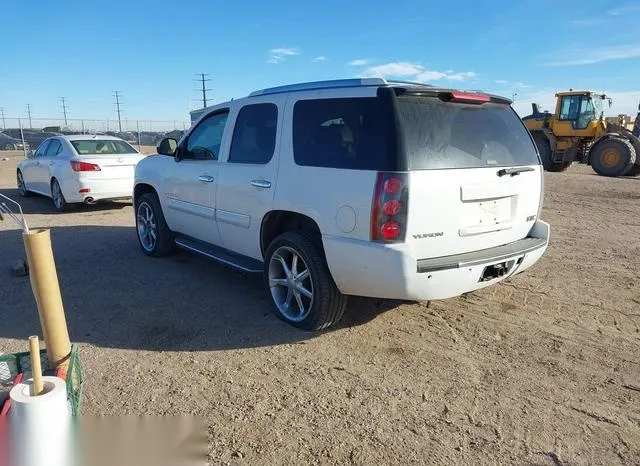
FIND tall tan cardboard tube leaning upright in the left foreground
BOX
[22,230,71,370]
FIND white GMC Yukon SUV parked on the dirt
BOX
[134,79,549,330]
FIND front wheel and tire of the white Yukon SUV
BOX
[135,193,175,257]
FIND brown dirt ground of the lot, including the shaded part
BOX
[0,153,640,465]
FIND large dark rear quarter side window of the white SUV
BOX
[293,97,395,171]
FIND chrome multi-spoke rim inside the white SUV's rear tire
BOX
[269,246,313,322]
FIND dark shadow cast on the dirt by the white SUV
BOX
[0,222,400,351]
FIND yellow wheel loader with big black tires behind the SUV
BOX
[522,90,640,176]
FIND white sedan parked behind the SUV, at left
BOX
[16,136,145,211]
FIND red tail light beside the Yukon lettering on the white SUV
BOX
[371,173,409,243]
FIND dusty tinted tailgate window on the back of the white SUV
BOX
[398,96,540,170]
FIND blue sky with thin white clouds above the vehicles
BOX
[0,0,640,124]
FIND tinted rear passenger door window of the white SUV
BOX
[229,103,278,164]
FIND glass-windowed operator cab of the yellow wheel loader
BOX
[554,91,611,137]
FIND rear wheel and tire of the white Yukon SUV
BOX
[264,232,347,330]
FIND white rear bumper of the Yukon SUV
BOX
[322,221,550,301]
